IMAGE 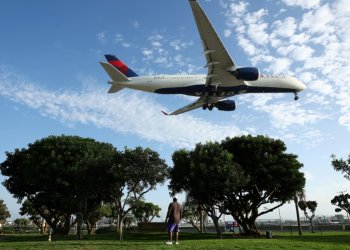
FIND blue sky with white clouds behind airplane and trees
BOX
[0,0,350,223]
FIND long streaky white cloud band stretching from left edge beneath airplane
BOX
[0,67,246,148]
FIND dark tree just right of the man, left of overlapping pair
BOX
[169,142,245,237]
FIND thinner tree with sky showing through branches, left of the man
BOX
[110,147,168,240]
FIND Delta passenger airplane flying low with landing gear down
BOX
[100,0,306,115]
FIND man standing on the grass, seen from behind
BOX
[165,196,182,245]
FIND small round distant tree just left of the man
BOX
[132,200,162,223]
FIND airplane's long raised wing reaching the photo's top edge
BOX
[189,0,244,86]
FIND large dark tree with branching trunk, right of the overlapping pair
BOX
[222,135,305,234]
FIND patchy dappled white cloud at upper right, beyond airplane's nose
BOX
[221,0,350,131]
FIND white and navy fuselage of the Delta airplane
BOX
[112,75,306,97]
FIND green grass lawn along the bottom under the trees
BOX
[0,232,350,250]
